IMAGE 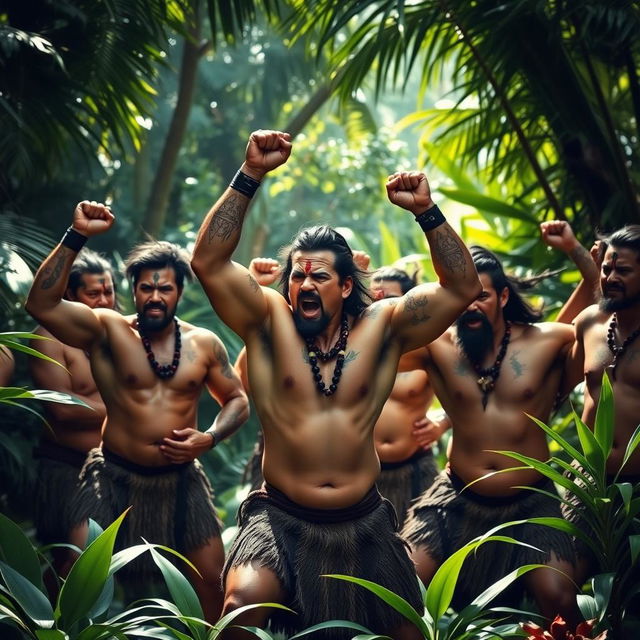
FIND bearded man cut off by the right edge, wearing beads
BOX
[571,225,640,580]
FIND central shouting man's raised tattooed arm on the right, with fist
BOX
[387,172,482,351]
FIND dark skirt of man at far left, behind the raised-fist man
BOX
[33,440,87,544]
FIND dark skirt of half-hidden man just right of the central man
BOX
[376,449,439,527]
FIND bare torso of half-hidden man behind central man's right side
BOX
[374,350,434,462]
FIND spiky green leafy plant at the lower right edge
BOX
[492,372,640,638]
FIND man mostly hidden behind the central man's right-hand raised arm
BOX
[369,267,446,526]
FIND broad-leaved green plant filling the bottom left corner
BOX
[0,511,286,640]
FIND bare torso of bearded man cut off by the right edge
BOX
[582,307,640,474]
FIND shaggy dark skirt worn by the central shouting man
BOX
[223,485,423,640]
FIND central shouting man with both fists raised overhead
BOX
[192,131,479,640]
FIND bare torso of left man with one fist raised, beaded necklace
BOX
[91,312,210,466]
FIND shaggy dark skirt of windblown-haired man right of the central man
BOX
[402,471,575,607]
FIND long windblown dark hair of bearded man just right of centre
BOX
[469,245,542,324]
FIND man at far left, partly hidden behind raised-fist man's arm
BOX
[29,248,116,576]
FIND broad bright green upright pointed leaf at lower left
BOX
[56,509,129,628]
